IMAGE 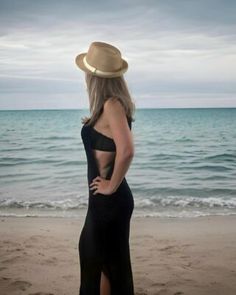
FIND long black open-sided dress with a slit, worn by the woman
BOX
[78,117,134,295]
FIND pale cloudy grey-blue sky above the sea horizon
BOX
[0,0,236,110]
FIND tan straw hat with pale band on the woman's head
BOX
[75,42,128,78]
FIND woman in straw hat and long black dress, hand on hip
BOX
[76,42,135,295]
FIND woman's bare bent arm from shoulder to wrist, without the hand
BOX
[103,99,134,193]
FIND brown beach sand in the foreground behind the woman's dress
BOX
[0,216,236,295]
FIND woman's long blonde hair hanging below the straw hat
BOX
[82,72,135,125]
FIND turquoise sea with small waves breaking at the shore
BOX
[0,109,236,217]
